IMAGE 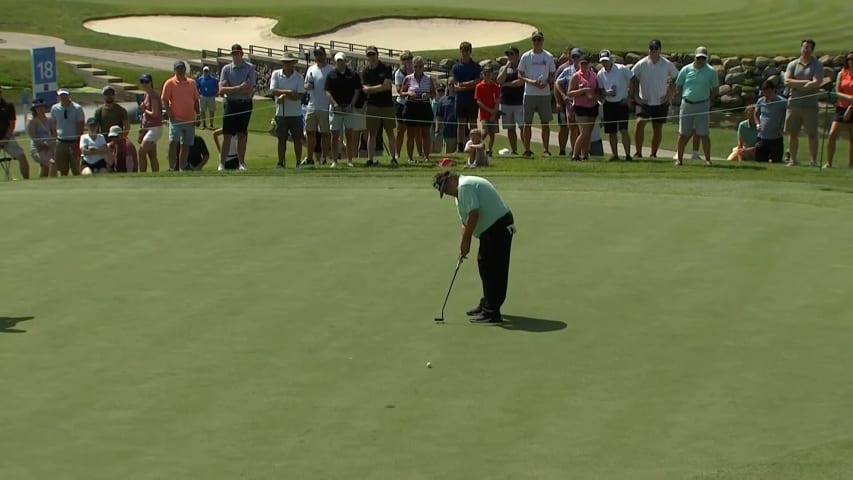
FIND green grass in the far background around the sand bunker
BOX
[0,0,851,59]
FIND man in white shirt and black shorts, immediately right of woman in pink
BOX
[598,50,634,161]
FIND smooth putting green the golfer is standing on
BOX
[0,176,853,480]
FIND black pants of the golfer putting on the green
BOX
[477,212,515,313]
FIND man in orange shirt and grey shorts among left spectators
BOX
[160,60,201,171]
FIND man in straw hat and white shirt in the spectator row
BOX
[270,52,305,168]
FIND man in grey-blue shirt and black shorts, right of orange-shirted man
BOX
[218,43,257,171]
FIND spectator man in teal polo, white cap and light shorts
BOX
[675,47,720,165]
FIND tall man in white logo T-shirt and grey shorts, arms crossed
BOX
[518,31,557,157]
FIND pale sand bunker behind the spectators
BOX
[83,15,536,51]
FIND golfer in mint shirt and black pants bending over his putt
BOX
[432,171,515,324]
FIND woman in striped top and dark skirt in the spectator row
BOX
[400,57,435,163]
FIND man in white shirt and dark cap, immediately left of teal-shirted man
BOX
[631,39,678,158]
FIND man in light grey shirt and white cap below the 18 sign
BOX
[50,88,86,177]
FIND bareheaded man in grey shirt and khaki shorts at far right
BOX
[785,39,823,167]
